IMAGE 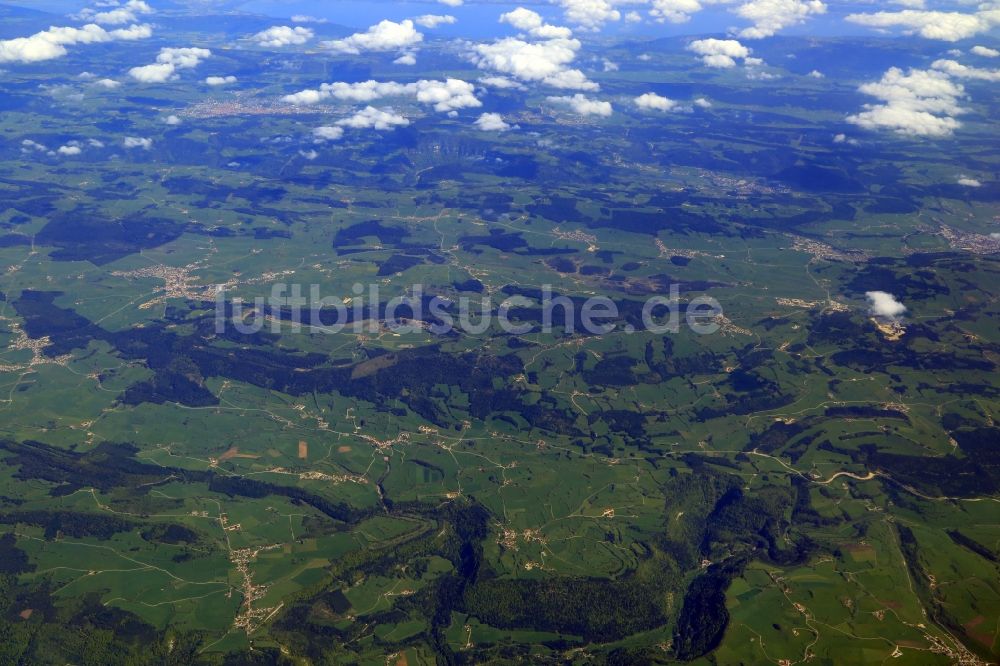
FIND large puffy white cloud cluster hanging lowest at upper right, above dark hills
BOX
[847,67,965,137]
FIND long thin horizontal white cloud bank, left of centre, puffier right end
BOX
[283,79,482,113]
